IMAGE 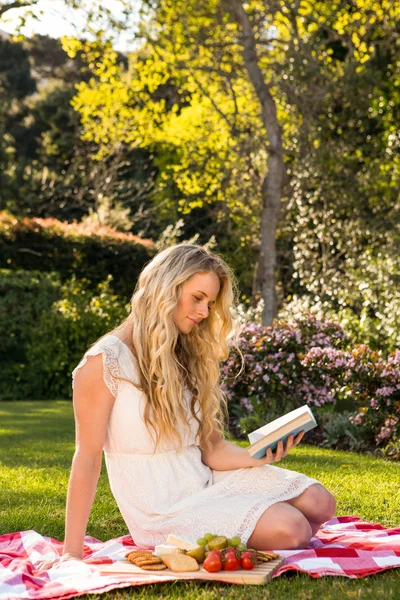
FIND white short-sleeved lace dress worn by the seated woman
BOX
[73,335,318,546]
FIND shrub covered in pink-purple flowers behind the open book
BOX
[222,315,400,448]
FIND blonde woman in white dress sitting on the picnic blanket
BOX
[35,244,335,568]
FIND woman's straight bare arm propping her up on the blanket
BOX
[38,355,114,570]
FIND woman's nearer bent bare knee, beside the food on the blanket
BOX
[247,502,312,550]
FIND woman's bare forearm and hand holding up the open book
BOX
[201,431,304,471]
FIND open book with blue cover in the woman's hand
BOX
[247,404,317,458]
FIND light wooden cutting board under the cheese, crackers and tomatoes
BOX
[100,558,284,585]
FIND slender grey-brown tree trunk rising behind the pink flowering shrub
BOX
[228,0,286,325]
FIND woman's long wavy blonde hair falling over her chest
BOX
[114,244,238,448]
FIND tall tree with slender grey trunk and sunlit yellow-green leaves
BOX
[67,0,395,324]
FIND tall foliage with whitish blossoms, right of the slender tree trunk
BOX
[280,8,400,342]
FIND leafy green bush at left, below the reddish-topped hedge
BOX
[0,270,127,400]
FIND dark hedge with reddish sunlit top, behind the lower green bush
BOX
[0,211,156,299]
